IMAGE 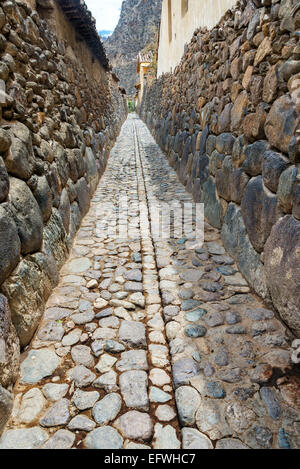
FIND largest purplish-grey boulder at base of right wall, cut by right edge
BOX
[265,215,300,337]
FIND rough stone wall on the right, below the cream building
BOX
[140,0,300,336]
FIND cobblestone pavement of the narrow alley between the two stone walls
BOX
[0,115,300,449]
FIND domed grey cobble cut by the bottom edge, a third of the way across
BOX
[84,426,123,449]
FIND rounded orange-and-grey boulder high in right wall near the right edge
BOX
[265,95,299,153]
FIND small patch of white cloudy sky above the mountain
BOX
[85,0,123,31]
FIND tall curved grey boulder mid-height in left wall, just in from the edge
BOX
[9,178,43,254]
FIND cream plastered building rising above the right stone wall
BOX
[157,0,237,77]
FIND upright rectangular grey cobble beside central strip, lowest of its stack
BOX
[120,370,149,411]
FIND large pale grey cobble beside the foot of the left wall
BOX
[21,349,60,384]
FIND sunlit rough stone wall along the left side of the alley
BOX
[0,0,127,430]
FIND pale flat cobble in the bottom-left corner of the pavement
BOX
[0,427,49,450]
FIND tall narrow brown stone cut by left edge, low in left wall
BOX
[0,294,20,388]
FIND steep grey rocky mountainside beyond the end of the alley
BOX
[105,0,162,96]
